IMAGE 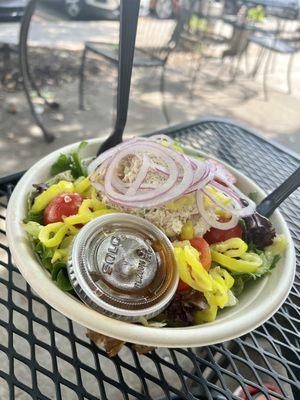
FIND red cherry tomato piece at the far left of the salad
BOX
[44,193,83,225]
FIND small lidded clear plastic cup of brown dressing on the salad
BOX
[68,213,178,321]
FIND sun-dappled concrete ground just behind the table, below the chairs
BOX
[0,46,300,175]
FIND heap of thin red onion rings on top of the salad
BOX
[89,135,255,220]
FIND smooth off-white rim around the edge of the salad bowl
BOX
[6,139,296,348]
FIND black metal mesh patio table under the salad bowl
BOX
[0,119,300,400]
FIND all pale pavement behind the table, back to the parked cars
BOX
[0,15,300,175]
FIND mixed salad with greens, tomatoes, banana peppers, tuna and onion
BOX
[24,135,286,327]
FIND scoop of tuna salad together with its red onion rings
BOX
[89,135,255,237]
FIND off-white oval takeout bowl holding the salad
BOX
[6,139,296,347]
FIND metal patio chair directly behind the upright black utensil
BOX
[79,8,188,123]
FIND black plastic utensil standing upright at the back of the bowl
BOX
[98,0,140,154]
